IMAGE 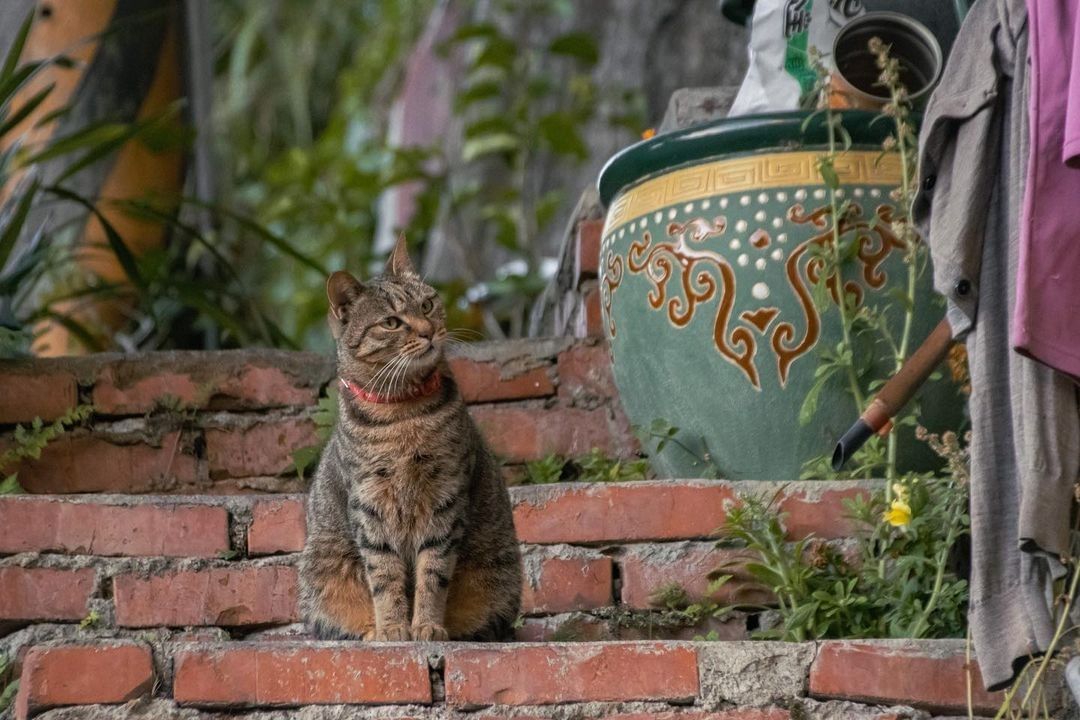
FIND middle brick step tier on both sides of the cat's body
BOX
[0,480,867,640]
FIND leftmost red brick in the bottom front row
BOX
[16,643,153,718]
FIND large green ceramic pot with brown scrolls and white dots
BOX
[599,111,959,479]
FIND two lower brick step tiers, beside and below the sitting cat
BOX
[0,480,1028,720]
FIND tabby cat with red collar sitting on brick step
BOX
[300,237,522,640]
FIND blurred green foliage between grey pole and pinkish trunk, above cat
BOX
[211,0,435,348]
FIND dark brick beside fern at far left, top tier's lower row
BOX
[5,432,198,493]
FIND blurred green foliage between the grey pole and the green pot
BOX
[206,0,644,348]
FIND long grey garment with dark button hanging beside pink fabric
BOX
[914,0,1080,690]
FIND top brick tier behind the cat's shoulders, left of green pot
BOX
[0,339,636,493]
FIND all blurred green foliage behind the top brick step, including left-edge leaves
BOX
[0,0,643,356]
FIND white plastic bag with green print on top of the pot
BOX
[728,0,865,116]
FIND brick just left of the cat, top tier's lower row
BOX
[206,419,319,477]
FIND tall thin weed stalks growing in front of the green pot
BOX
[799,38,941,487]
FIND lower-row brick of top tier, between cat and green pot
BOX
[470,405,633,462]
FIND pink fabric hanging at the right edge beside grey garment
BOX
[1012,0,1080,378]
